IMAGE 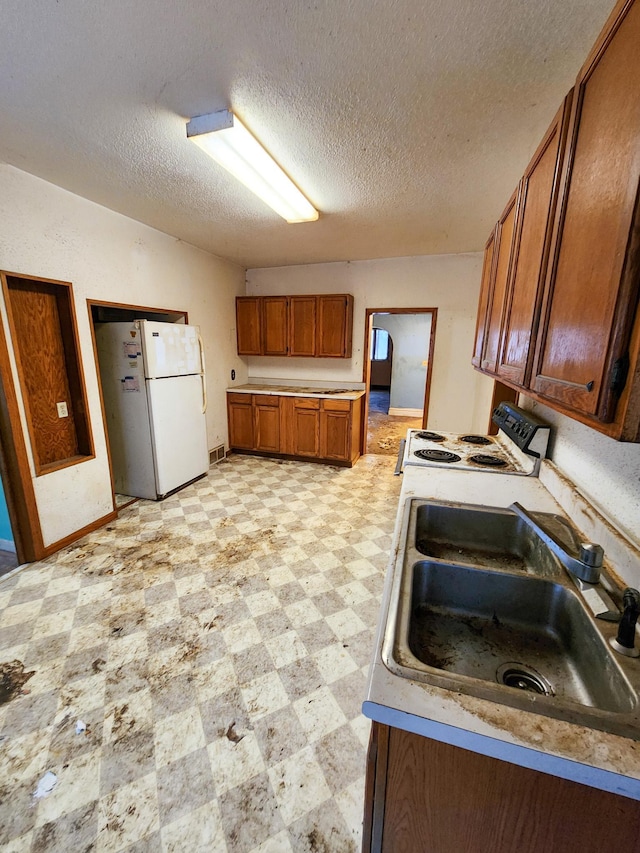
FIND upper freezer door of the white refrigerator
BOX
[140,320,202,379]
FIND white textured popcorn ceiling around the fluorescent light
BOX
[0,0,613,267]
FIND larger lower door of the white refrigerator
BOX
[147,374,209,497]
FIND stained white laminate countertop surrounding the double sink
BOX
[363,462,640,800]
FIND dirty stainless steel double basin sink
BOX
[383,498,640,739]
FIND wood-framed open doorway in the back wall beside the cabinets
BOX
[363,308,437,456]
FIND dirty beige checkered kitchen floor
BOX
[0,456,399,853]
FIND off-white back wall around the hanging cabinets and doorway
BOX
[247,253,493,432]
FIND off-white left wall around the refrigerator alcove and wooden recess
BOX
[0,164,247,545]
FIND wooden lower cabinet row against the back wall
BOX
[227,392,362,466]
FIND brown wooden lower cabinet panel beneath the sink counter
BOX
[362,722,640,853]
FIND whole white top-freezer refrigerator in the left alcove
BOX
[96,320,209,500]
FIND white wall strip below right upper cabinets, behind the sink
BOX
[520,396,640,548]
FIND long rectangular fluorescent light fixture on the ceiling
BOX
[187,110,318,222]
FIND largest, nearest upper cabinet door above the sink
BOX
[533,2,640,423]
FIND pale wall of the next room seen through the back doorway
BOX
[373,314,431,409]
